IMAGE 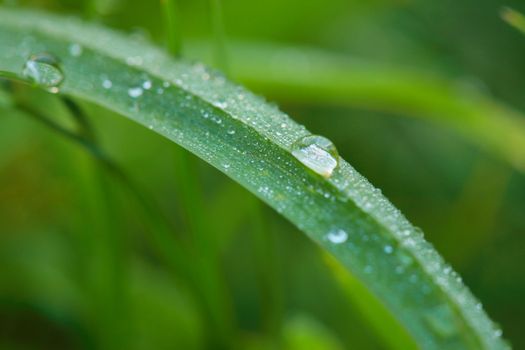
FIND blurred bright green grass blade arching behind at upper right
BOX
[213,43,525,173]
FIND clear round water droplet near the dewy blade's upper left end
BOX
[22,53,64,94]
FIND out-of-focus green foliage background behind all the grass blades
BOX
[0,0,525,349]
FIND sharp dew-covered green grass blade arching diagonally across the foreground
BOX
[0,10,506,349]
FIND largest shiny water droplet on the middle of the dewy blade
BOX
[292,135,339,178]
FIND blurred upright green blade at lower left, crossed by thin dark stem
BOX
[56,100,131,349]
